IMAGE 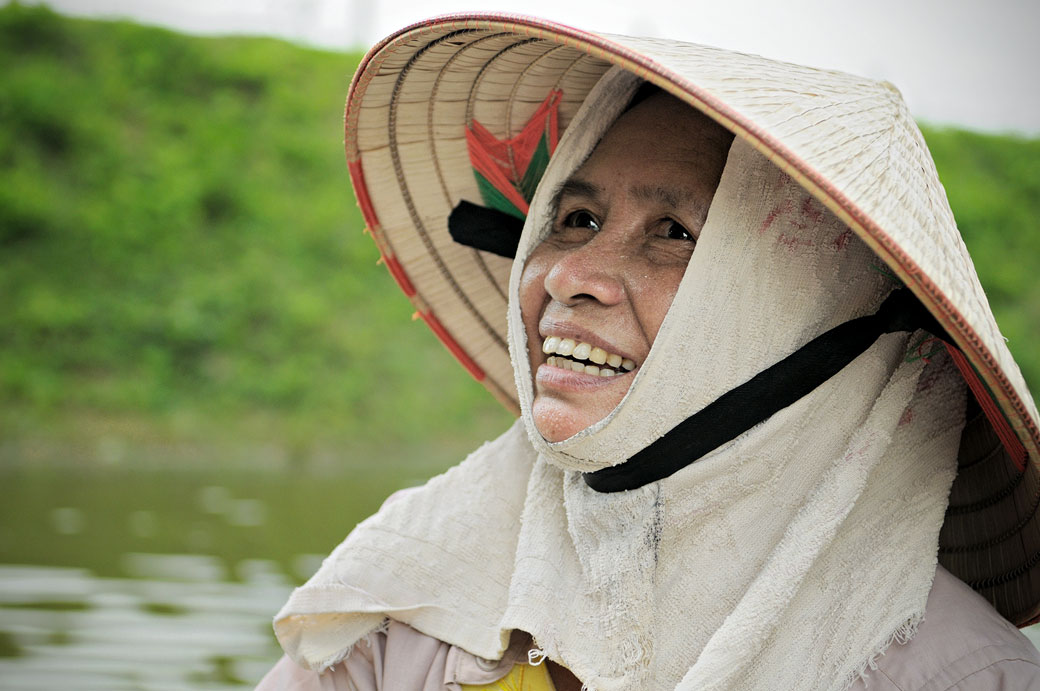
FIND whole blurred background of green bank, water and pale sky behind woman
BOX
[0,0,1040,690]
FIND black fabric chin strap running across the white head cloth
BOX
[584,288,945,492]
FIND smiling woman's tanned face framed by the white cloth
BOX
[520,94,732,441]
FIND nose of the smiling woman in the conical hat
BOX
[545,231,629,305]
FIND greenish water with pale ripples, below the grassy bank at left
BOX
[0,463,433,691]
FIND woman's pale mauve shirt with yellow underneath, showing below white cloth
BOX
[257,566,1040,691]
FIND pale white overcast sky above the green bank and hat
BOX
[32,0,1040,134]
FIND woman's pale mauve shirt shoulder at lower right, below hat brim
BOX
[852,566,1040,691]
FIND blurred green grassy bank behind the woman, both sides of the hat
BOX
[0,4,1040,464]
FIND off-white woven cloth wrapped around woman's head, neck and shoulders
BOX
[276,69,964,691]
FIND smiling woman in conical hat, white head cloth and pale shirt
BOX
[261,12,1040,691]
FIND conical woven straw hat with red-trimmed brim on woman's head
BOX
[346,14,1040,625]
